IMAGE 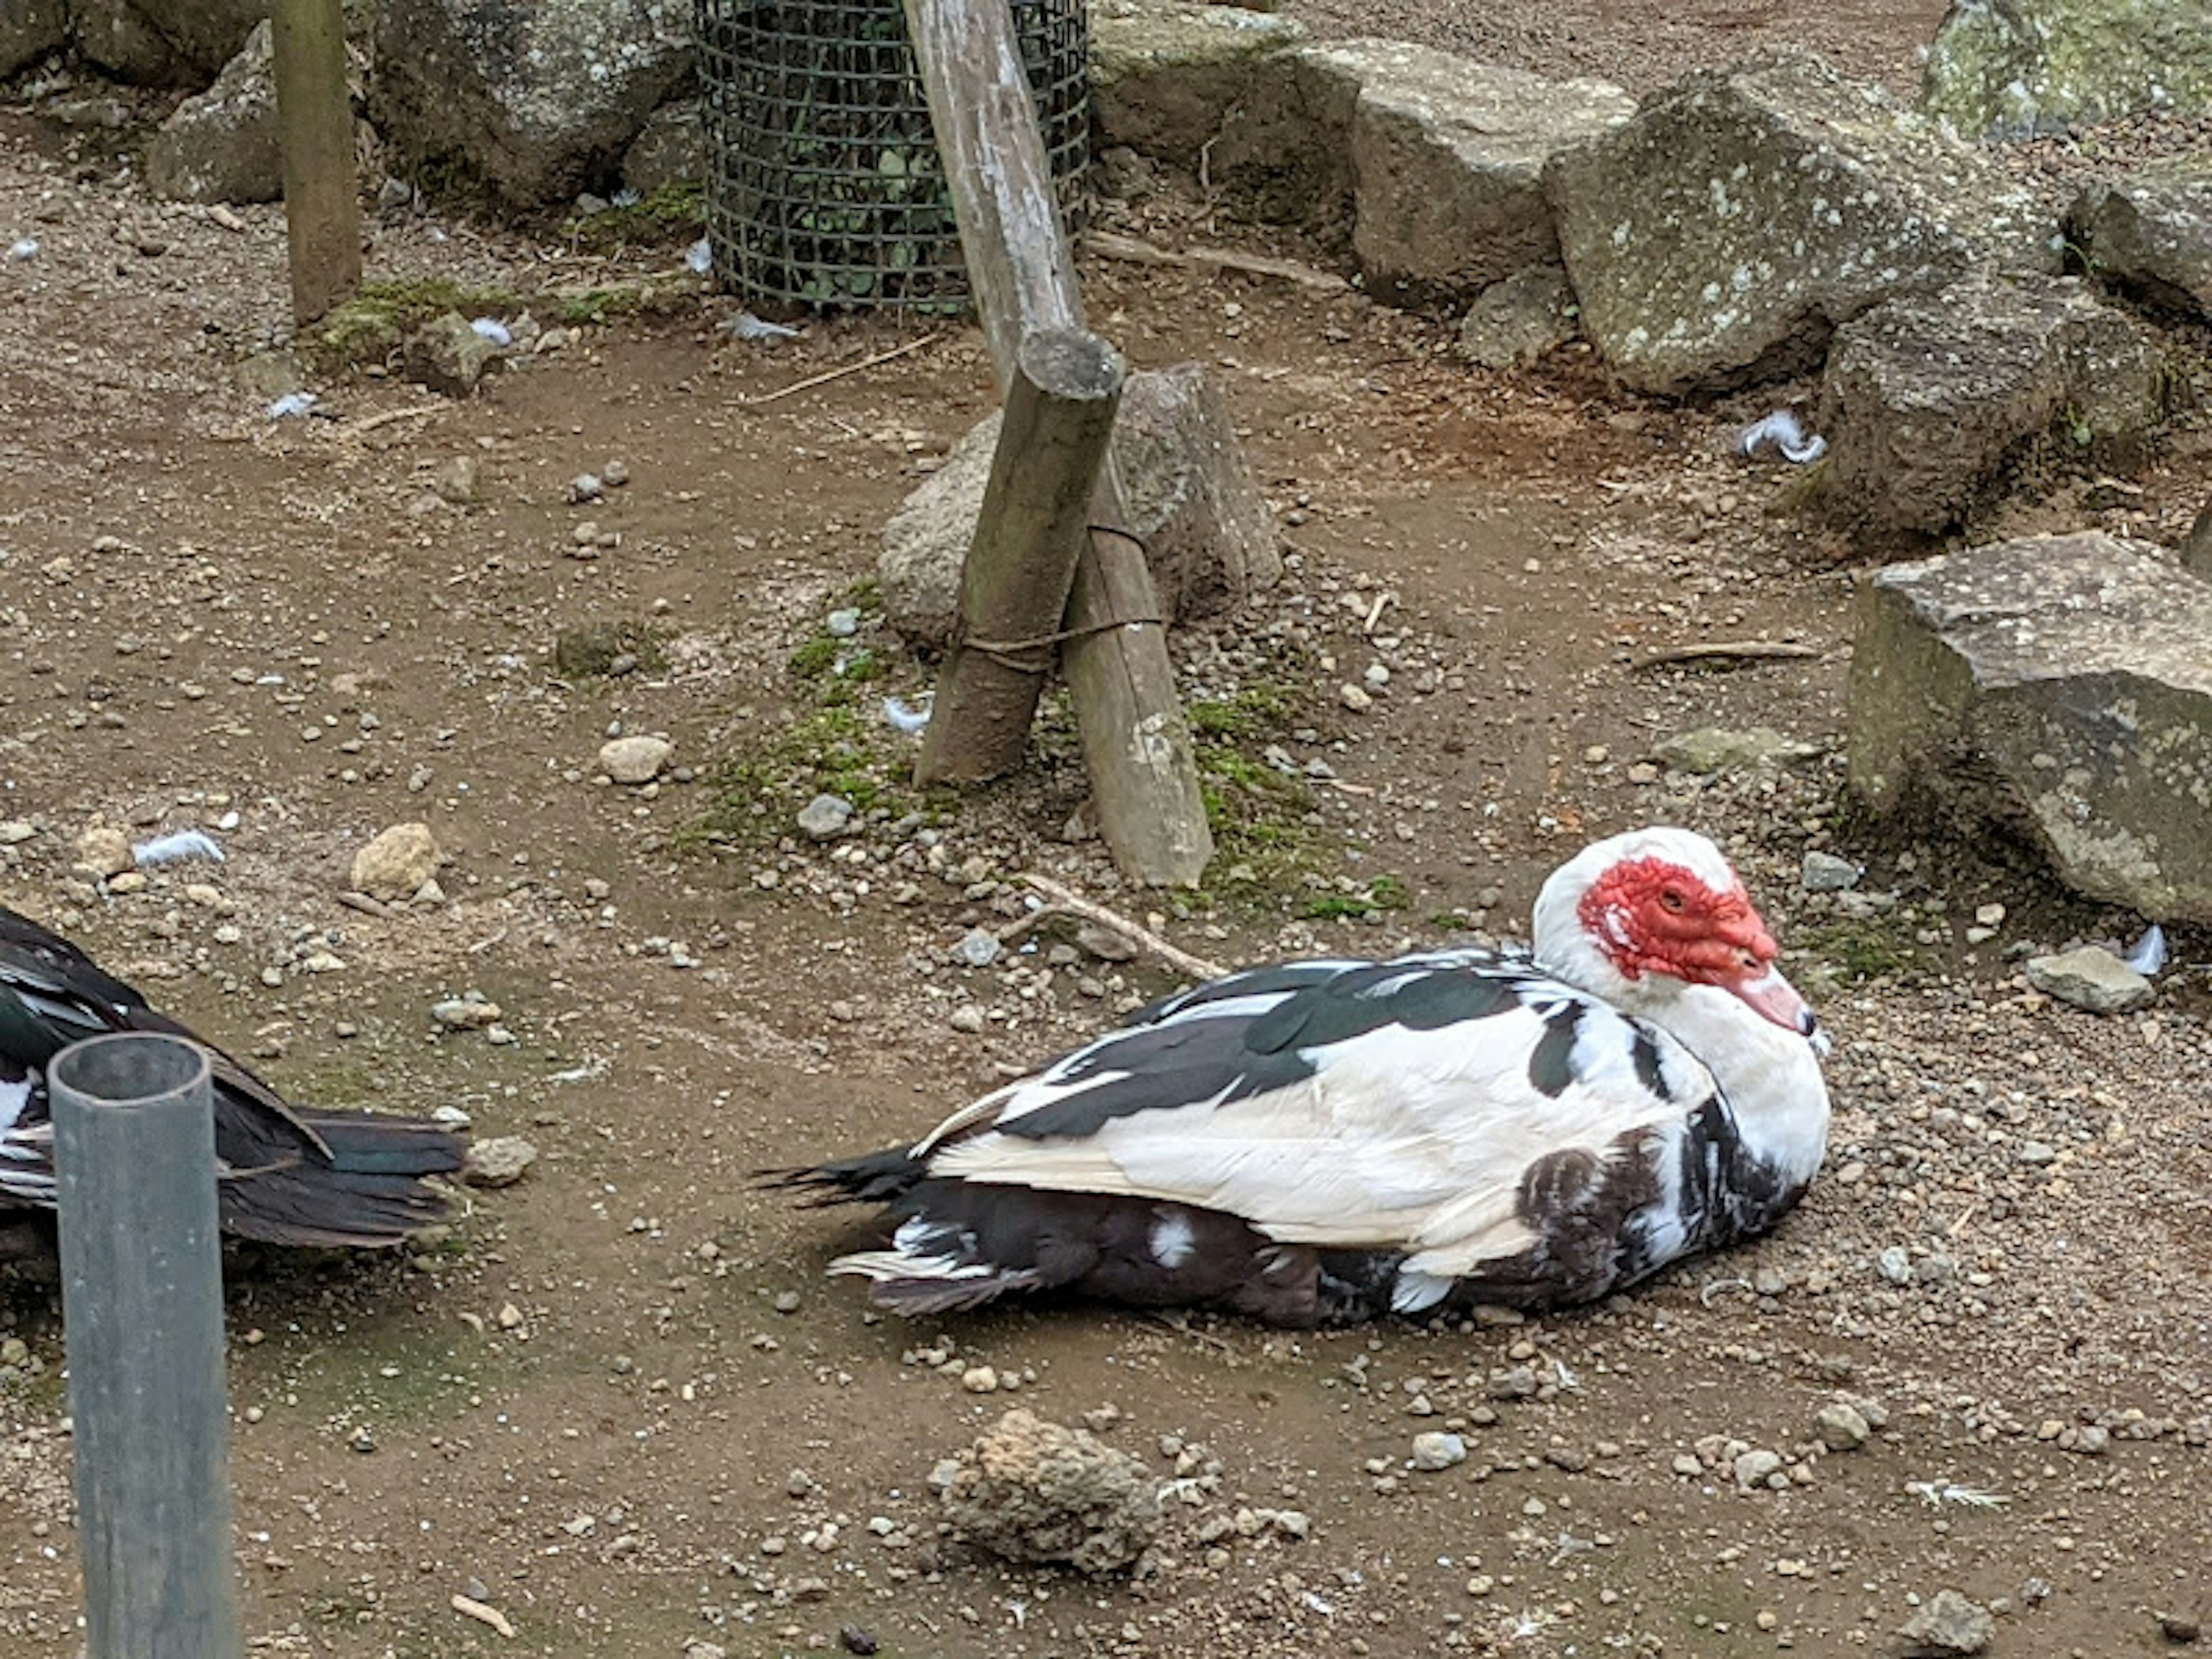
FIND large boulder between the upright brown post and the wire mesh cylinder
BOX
[372,0,697,206]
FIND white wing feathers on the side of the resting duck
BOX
[931,998,1712,1274]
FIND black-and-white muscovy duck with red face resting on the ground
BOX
[767,827,1827,1325]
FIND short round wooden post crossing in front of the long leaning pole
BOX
[914,329,1122,783]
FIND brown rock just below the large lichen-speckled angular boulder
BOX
[1820,276,2161,535]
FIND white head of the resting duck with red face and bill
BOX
[1535,825,1827,1053]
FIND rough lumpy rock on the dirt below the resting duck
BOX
[942,1411,1159,1573]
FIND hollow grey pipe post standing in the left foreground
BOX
[47,1033,241,1659]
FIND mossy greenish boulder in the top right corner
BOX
[1920,0,2212,137]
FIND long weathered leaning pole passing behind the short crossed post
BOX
[905,0,1214,887]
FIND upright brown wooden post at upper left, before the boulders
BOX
[270,0,361,323]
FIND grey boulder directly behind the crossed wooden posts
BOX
[876,363,1283,648]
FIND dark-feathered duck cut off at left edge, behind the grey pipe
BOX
[0,905,464,1248]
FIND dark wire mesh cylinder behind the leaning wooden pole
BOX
[699,0,1090,312]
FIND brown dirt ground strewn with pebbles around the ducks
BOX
[0,0,2212,1659]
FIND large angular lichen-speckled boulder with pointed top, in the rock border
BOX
[1544,53,2057,394]
